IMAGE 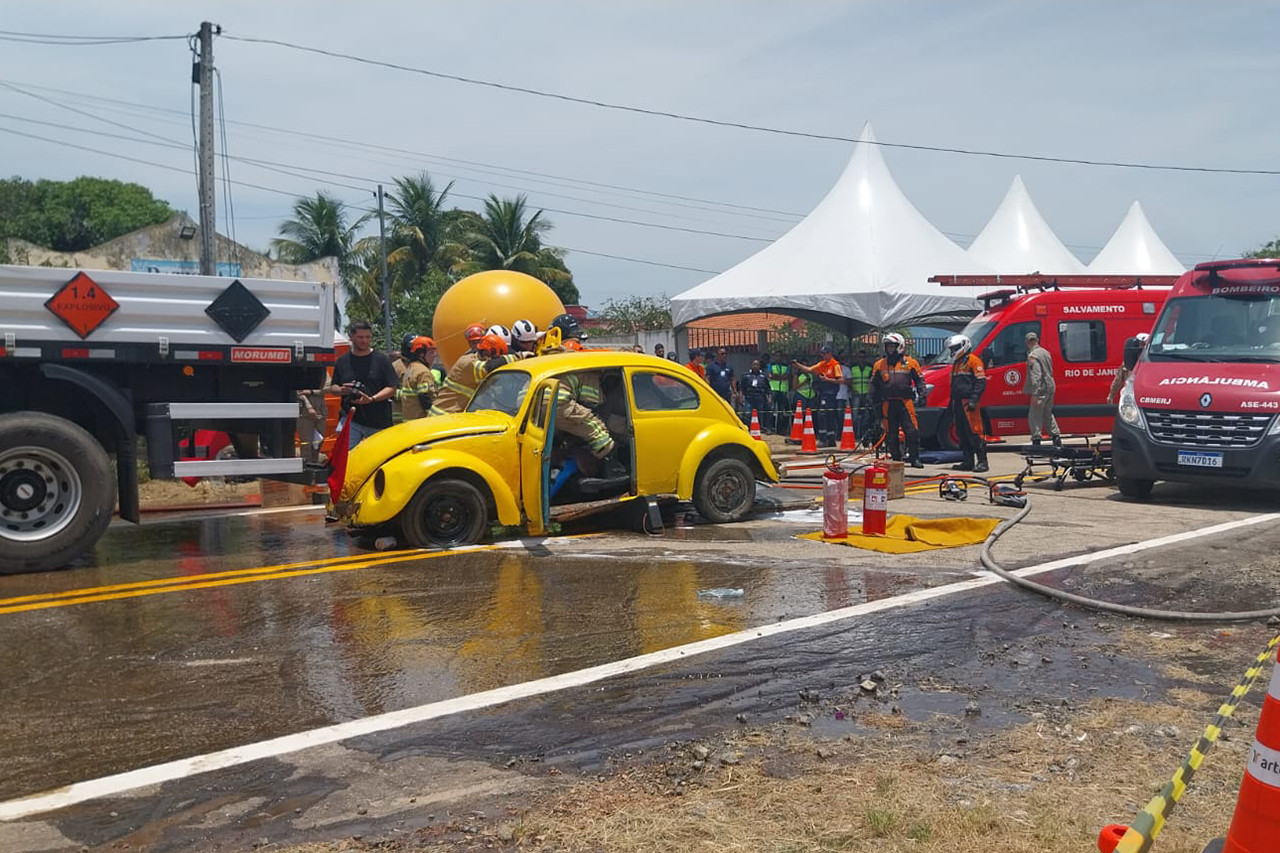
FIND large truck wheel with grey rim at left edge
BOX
[0,412,115,574]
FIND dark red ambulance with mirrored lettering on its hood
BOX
[1111,259,1280,500]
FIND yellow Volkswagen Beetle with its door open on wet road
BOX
[335,351,778,547]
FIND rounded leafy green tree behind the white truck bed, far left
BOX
[0,177,174,252]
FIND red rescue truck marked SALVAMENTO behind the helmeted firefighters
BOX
[916,275,1176,448]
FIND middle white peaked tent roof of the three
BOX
[969,175,1084,275]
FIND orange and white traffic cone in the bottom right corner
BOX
[1222,645,1280,853]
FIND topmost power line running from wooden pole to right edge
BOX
[221,31,1280,175]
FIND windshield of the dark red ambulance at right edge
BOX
[1147,293,1280,361]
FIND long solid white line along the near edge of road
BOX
[0,512,1280,821]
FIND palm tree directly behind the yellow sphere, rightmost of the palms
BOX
[463,195,579,302]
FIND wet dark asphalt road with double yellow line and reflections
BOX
[0,473,1280,849]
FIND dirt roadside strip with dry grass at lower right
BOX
[259,626,1275,853]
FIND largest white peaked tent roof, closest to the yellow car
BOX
[671,124,991,334]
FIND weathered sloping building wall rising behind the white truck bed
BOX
[8,214,338,283]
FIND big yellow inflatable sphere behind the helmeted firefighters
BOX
[431,269,564,369]
